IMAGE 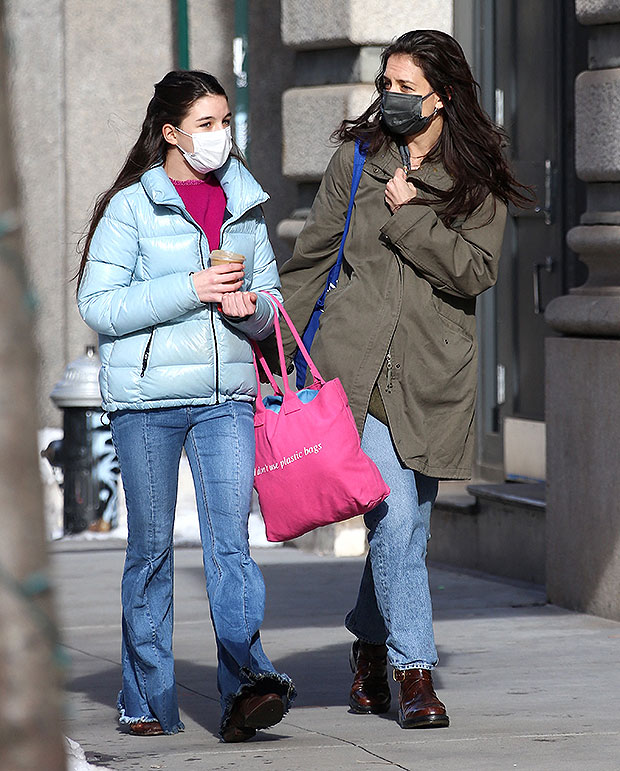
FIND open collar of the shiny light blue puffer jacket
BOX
[140,158,269,219]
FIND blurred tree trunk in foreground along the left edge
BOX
[0,10,65,771]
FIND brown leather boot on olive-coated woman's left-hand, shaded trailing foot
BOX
[349,640,391,715]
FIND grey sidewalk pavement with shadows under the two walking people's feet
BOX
[50,540,620,771]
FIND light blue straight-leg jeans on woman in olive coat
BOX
[345,415,439,669]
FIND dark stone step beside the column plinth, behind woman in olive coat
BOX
[428,482,545,584]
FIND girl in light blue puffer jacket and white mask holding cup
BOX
[78,71,294,742]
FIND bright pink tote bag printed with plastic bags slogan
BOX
[254,292,390,541]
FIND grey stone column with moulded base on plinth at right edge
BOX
[545,0,620,620]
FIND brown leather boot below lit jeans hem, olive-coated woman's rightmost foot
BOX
[394,669,450,728]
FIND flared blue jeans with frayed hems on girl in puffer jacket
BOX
[110,401,294,733]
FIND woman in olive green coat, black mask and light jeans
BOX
[274,30,526,728]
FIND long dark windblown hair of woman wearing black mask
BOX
[333,30,532,225]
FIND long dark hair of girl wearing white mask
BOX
[75,70,234,288]
